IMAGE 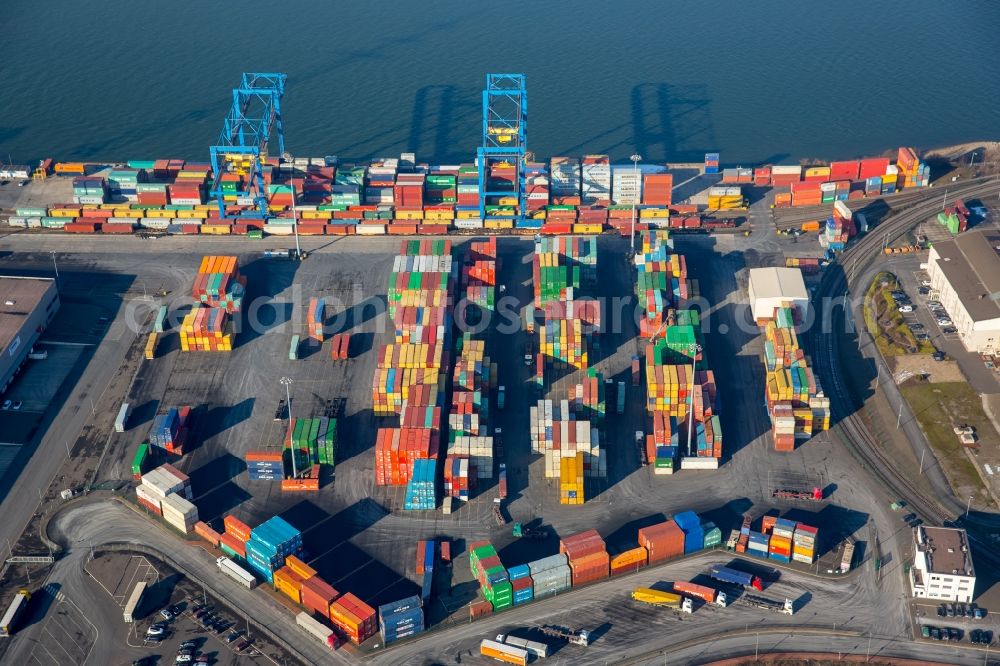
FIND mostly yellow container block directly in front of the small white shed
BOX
[759,308,830,451]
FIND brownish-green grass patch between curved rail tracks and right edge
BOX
[899,380,1000,499]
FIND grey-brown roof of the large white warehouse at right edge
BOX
[934,230,1000,321]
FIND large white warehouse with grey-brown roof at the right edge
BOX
[927,231,1000,354]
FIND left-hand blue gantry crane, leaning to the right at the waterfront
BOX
[209,72,287,217]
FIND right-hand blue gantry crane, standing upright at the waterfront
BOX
[476,74,528,222]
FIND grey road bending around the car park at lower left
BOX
[6,500,352,666]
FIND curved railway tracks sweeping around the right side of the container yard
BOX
[808,179,1000,528]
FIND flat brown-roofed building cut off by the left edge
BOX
[0,276,59,394]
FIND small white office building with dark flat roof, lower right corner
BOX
[910,526,976,603]
